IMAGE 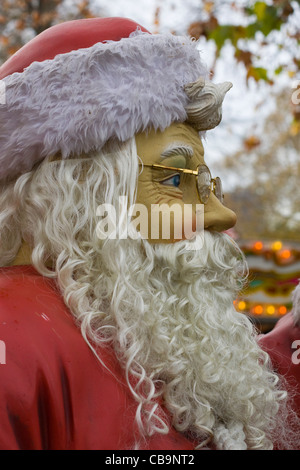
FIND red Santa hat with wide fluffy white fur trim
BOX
[0,18,206,181]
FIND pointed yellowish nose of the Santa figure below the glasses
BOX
[204,194,236,232]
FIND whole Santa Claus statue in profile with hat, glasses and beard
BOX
[0,18,299,450]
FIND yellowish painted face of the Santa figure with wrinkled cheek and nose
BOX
[136,123,236,243]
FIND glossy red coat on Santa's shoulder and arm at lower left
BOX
[0,266,194,450]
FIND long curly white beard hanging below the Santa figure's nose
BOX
[72,233,298,449]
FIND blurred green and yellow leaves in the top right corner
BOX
[189,0,300,84]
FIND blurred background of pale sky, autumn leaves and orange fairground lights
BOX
[0,0,300,332]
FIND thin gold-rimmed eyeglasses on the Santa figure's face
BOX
[140,163,224,204]
